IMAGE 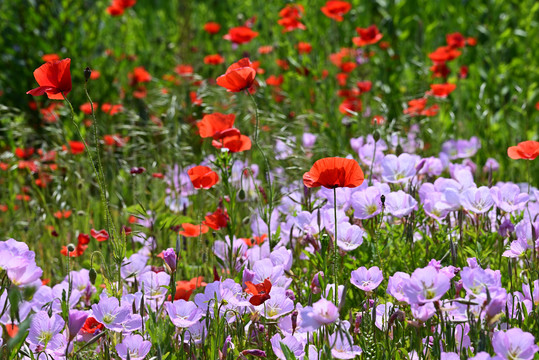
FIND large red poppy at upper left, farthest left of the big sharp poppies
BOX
[26,58,71,100]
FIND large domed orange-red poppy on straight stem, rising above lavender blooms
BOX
[303,157,364,189]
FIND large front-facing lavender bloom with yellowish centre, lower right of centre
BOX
[403,266,451,305]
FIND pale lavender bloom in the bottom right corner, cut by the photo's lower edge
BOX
[492,328,539,360]
